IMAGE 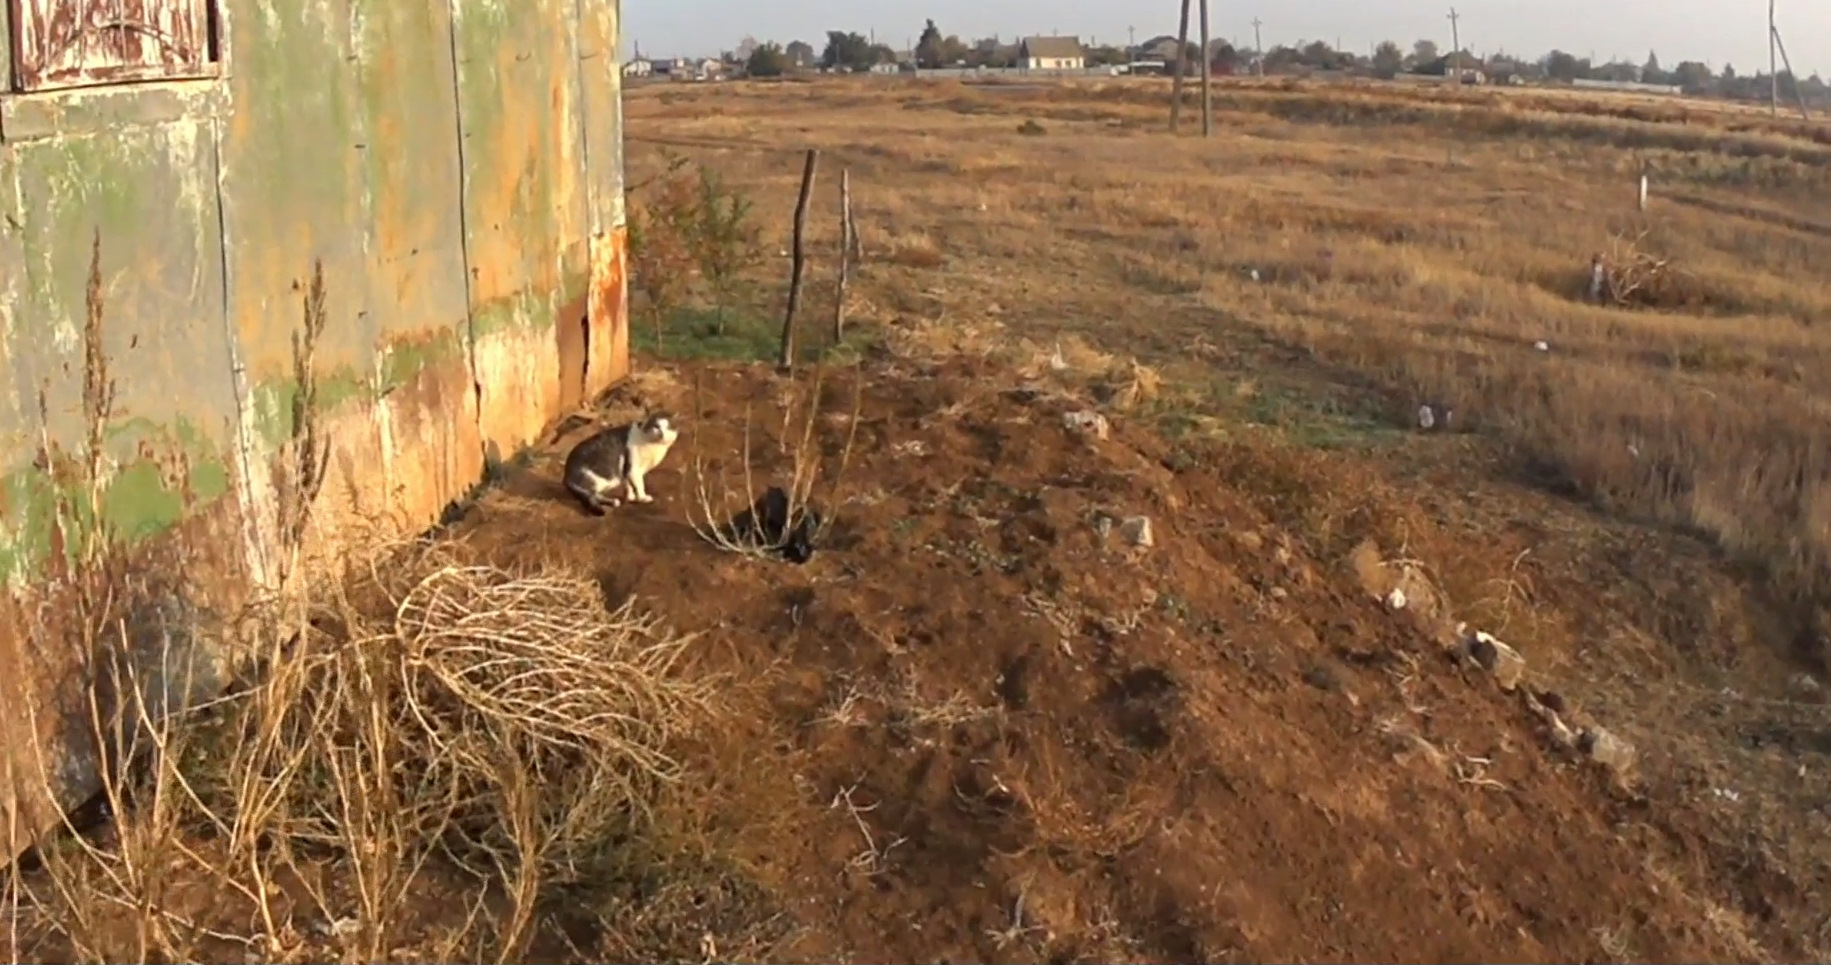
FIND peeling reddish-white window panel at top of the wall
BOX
[9,0,216,90]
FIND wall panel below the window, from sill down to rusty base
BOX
[0,119,240,853]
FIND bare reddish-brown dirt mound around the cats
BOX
[439,359,1798,961]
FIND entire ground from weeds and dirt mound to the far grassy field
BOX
[9,81,1831,961]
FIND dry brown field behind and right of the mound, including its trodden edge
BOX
[604,81,1831,958]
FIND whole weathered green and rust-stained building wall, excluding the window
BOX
[0,0,628,853]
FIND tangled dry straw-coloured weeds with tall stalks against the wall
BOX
[5,252,712,961]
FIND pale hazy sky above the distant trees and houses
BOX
[623,0,1831,77]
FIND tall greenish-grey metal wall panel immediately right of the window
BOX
[220,0,386,562]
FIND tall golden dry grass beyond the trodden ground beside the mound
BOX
[628,81,1831,633]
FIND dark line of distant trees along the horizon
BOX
[706,20,1831,104]
